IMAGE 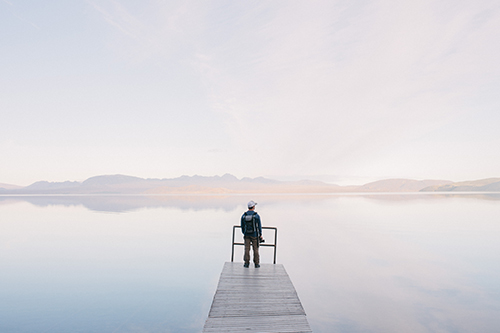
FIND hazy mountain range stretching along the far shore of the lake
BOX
[0,174,500,194]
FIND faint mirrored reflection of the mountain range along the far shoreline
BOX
[0,193,500,213]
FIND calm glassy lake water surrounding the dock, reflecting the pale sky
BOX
[0,194,500,332]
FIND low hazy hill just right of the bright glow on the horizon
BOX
[357,179,452,192]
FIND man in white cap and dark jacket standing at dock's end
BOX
[241,200,262,268]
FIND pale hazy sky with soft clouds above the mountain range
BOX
[0,0,500,185]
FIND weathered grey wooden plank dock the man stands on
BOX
[203,262,312,333]
